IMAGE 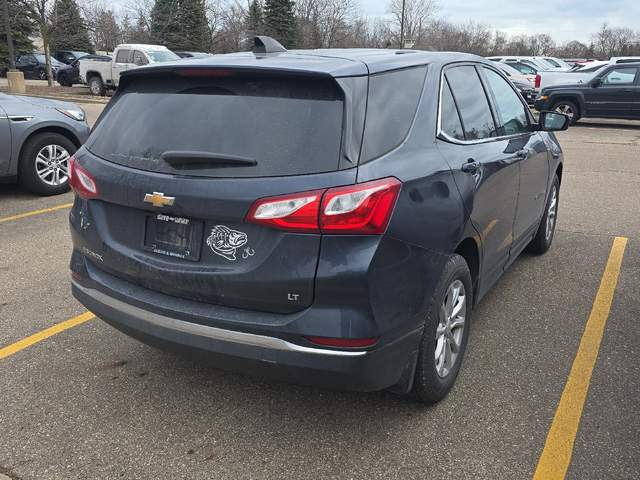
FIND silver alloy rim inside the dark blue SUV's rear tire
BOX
[435,280,467,378]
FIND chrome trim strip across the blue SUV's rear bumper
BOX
[72,280,367,357]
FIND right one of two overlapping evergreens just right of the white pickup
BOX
[175,0,209,52]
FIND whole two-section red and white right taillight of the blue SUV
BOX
[245,177,402,235]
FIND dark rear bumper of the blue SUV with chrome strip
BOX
[72,267,422,392]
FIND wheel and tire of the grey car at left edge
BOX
[18,132,77,196]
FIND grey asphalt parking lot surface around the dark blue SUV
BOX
[0,105,640,479]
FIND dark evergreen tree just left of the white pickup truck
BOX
[50,0,95,53]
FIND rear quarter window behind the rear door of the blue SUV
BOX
[362,67,427,162]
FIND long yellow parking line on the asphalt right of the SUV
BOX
[533,237,627,480]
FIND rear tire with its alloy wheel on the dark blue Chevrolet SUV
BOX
[412,254,473,404]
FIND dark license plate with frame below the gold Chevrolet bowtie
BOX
[142,213,203,262]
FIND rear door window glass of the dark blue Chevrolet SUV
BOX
[445,65,497,140]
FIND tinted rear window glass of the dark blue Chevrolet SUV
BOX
[87,78,343,177]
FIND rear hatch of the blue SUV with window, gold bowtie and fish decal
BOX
[74,74,356,313]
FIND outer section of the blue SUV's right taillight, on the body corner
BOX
[320,178,402,235]
